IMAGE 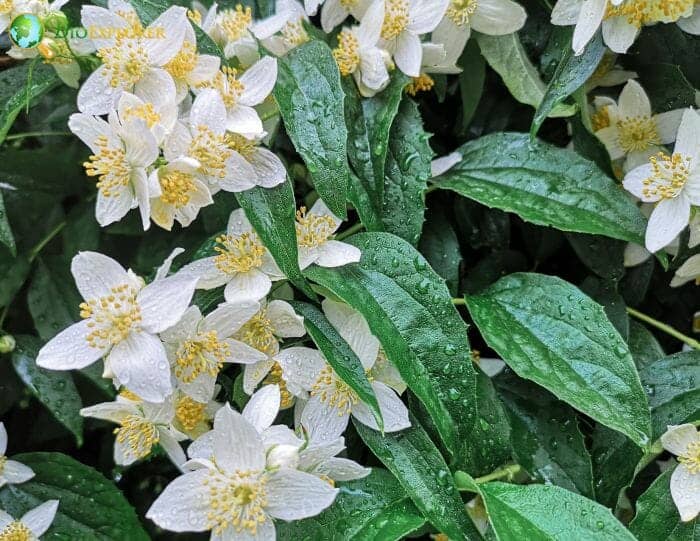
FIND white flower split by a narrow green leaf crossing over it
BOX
[292,299,410,441]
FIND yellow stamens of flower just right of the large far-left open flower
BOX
[175,331,231,383]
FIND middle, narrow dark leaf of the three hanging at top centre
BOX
[343,73,408,231]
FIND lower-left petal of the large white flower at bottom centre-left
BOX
[146,469,211,532]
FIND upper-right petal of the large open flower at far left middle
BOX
[136,273,197,333]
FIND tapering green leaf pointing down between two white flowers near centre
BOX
[236,178,315,298]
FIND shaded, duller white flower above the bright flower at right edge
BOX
[595,79,683,170]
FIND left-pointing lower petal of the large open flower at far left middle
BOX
[36,320,107,370]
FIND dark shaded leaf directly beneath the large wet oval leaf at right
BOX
[495,375,594,498]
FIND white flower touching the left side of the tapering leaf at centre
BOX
[180,209,284,302]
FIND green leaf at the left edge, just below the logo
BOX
[0,61,61,143]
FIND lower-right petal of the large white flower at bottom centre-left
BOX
[266,468,338,520]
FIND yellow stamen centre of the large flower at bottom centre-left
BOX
[207,470,267,536]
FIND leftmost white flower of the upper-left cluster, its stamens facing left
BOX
[68,108,159,230]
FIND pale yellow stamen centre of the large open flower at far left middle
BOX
[80,284,141,349]
